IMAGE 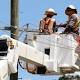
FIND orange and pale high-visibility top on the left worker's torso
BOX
[39,17,56,34]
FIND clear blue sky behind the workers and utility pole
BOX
[0,0,80,80]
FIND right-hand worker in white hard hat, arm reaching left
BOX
[60,5,79,34]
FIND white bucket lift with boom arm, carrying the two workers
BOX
[0,32,79,80]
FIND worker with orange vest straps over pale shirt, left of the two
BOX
[39,8,57,34]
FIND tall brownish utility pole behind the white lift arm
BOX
[10,0,19,80]
